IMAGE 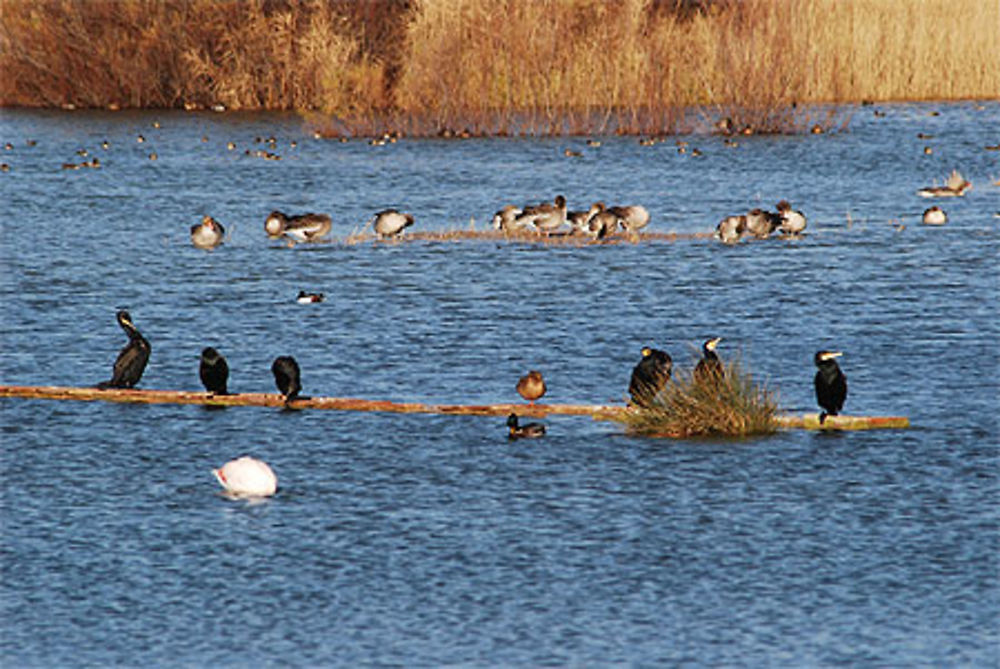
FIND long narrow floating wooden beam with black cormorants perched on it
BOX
[0,385,910,430]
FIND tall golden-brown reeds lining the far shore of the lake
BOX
[0,0,1000,134]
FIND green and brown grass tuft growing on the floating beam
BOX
[620,360,778,437]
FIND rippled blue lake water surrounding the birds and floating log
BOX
[0,102,1000,667]
